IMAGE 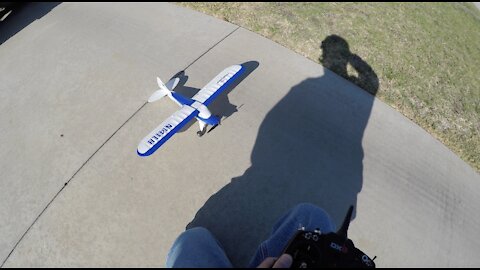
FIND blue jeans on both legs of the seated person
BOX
[166,203,335,268]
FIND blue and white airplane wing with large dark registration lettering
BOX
[137,106,198,156]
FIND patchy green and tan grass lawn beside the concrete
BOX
[177,2,480,172]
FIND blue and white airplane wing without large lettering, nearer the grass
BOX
[192,65,245,106]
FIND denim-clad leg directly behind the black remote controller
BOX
[250,203,335,267]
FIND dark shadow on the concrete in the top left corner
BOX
[0,2,61,45]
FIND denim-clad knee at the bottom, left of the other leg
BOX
[166,227,232,268]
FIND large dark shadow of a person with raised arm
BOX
[187,35,378,267]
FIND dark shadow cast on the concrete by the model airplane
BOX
[171,61,259,132]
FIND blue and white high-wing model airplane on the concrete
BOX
[137,65,245,156]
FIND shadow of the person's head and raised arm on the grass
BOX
[319,35,378,95]
